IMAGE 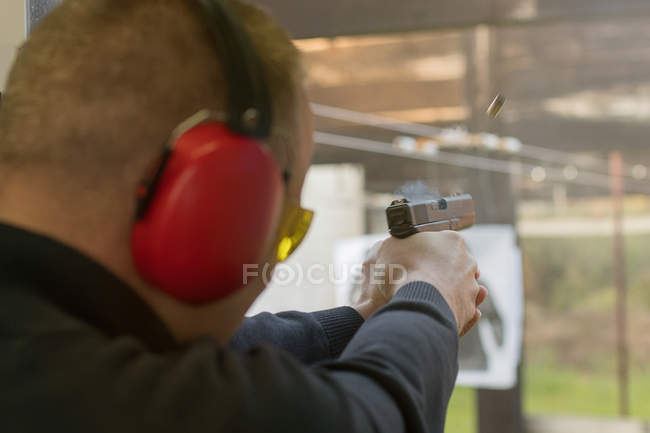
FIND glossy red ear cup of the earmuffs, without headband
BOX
[132,116,284,303]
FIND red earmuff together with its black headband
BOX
[131,0,286,303]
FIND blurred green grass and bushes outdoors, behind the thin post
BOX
[446,235,650,433]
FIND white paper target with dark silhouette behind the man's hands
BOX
[334,225,524,388]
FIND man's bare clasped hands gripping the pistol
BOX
[355,231,487,336]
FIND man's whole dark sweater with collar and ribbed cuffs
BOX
[0,226,458,433]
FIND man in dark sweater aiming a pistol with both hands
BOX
[0,0,486,432]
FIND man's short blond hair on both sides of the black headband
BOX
[0,0,302,176]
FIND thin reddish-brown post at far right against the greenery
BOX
[609,152,629,416]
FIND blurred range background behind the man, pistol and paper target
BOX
[0,0,650,433]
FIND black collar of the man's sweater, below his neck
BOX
[0,224,177,352]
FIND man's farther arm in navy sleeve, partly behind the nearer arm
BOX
[229,307,363,364]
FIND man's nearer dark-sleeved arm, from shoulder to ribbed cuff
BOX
[6,282,458,433]
